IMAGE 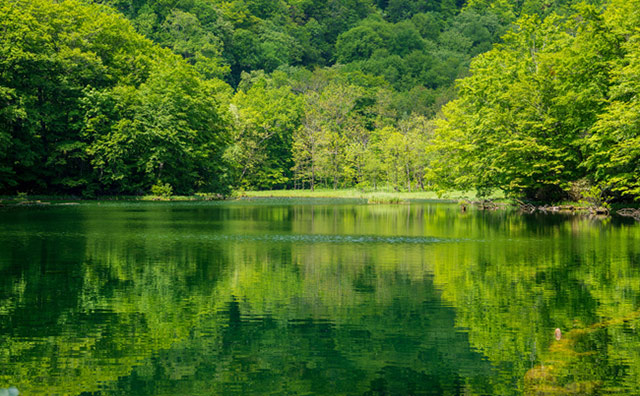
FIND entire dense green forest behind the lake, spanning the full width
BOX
[0,0,640,200]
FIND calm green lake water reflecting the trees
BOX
[0,200,640,395]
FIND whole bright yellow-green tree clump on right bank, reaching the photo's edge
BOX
[430,1,640,200]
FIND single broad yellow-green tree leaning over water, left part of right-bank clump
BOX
[431,10,604,199]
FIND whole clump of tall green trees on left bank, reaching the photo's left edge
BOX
[0,0,228,195]
